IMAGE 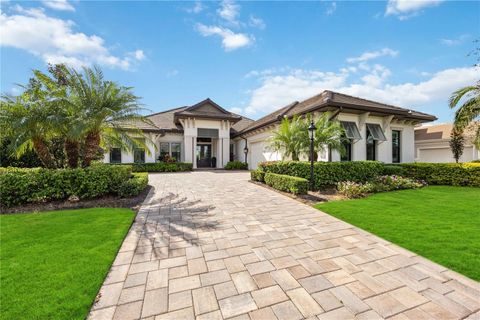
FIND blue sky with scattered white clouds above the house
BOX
[0,0,480,122]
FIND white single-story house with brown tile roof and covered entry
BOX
[104,91,436,169]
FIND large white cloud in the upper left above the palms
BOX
[0,6,144,70]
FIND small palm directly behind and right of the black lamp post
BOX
[301,112,345,161]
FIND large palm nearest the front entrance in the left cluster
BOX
[67,67,151,167]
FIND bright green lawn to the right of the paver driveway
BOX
[316,186,480,281]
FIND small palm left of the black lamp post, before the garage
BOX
[268,116,308,161]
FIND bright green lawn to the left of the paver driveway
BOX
[0,208,135,319]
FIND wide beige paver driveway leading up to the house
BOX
[90,171,480,320]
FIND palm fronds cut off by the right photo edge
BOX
[450,81,480,148]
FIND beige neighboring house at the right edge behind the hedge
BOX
[415,123,480,162]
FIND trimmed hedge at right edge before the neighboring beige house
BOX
[400,163,480,187]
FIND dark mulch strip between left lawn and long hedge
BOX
[0,186,152,214]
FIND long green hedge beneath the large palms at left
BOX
[0,165,148,213]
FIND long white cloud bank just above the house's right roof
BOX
[243,65,478,116]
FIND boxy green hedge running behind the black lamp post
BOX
[259,161,384,189]
